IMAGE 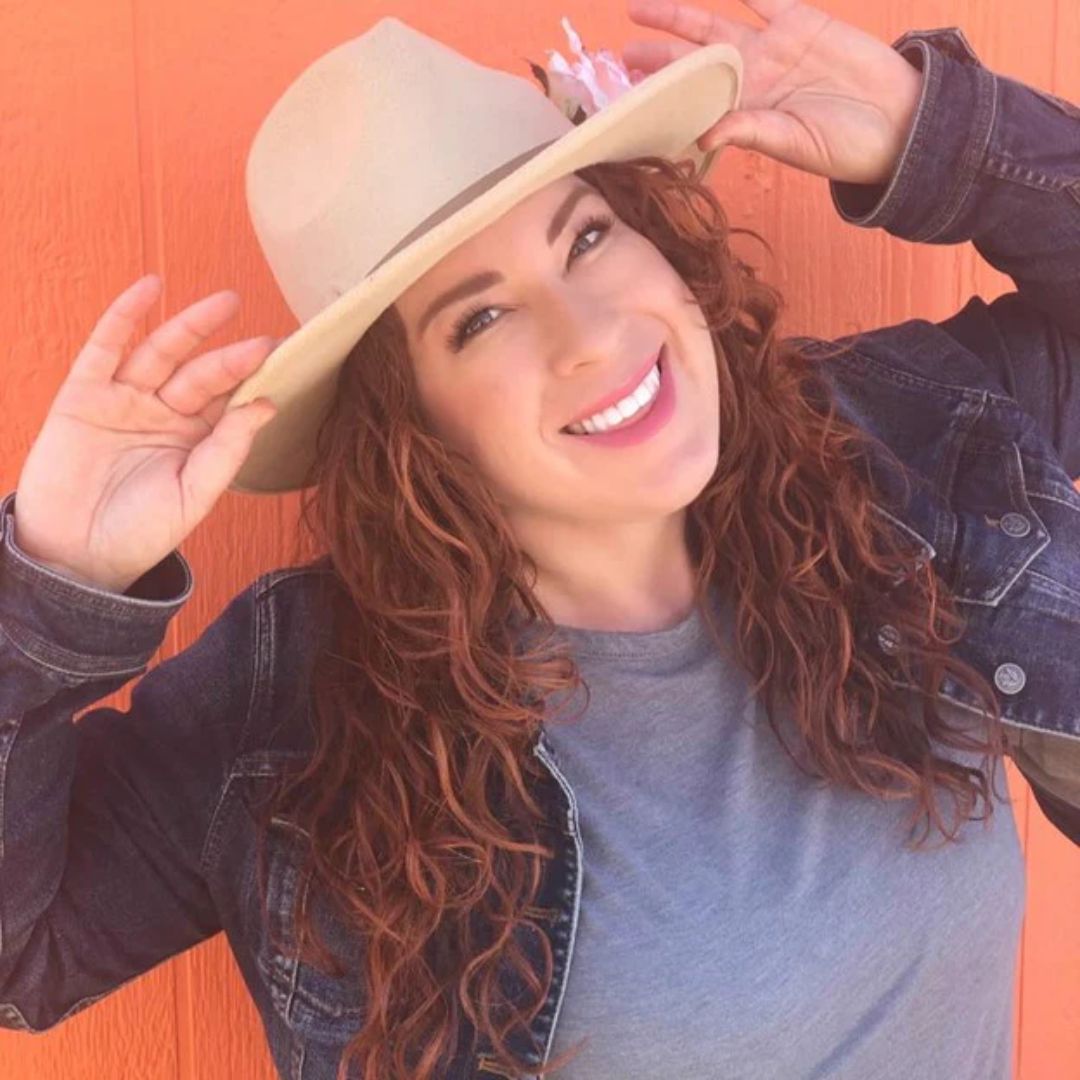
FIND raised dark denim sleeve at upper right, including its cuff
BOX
[829,27,1080,476]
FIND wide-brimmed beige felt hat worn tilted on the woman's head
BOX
[228,17,742,495]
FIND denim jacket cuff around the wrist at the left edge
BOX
[0,491,194,678]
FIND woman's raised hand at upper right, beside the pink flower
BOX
[622,0,923,184]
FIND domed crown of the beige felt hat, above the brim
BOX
[245,16,573,323]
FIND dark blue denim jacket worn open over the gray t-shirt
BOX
[0,27,1080,1080]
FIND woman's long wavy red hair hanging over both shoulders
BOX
[252,157,1003,1080]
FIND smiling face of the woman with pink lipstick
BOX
[396,175,719,535]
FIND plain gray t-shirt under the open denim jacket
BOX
[531,587,1025,1080]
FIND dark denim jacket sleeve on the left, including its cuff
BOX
[0,492,254,1031]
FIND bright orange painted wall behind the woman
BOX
[0,0,1080,1080]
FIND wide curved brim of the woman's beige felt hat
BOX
[226,42,743,495]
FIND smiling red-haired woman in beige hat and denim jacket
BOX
[0,0,1080,1080]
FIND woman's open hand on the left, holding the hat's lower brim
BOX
[14,274,278,593]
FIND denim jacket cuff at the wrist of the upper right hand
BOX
[828,27,995,242]
